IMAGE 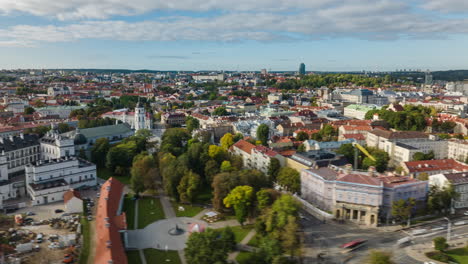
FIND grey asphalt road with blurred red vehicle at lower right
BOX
[301,208,421,264]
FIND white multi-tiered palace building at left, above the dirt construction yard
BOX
[25,157,97,205]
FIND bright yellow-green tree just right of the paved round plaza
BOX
[223,185,253,225]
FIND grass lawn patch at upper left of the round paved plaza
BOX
[138,197,166,229]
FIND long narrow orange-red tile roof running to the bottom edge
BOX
[94,178,128,264]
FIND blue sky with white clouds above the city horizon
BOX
[0,0,468,71]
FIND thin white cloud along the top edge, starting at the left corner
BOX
[0,0,336,20]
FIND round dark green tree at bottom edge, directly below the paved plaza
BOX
[184,229,230,264]
